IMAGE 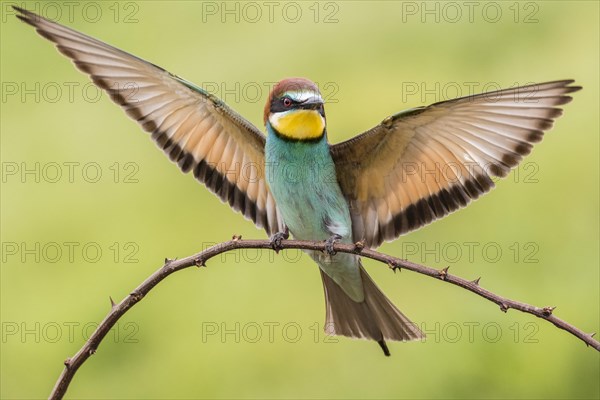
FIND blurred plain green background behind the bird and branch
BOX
[0,1,600,399]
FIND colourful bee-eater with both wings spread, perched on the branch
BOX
[13,6,581,356]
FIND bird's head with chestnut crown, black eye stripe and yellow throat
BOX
[264,78,325,141]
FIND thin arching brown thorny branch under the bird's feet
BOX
[50,236,600,399]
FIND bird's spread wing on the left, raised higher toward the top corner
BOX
[15,7,283,234]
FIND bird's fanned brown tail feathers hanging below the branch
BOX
[319,266,425,356]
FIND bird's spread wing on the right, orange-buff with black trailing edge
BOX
[331,80,581,247]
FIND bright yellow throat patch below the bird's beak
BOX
[269,110,325,140]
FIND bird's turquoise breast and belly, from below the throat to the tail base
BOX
[265,124,364,301]
